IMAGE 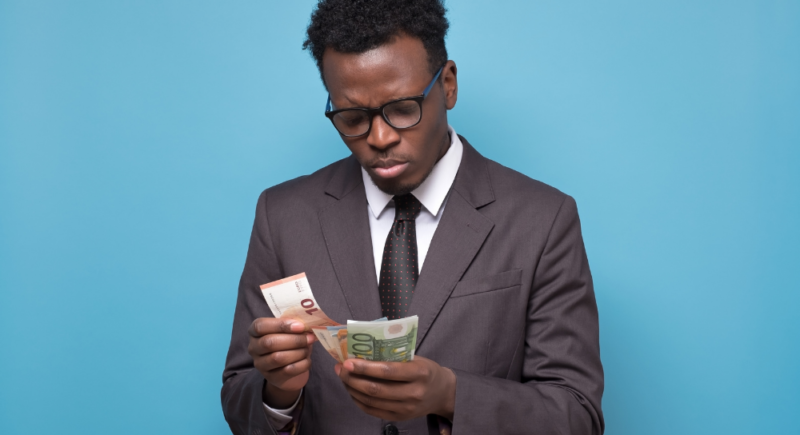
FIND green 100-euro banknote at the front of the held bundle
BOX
[340,316,419,362]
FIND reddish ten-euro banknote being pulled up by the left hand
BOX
[260,273,339,331]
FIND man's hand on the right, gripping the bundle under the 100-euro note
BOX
[334,356,456,421]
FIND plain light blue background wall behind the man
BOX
[0,0,800,435]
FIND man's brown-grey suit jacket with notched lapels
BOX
[222,138,604,435]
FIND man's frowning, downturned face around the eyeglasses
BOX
[323,35,458,195]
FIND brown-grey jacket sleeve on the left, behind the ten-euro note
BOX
[221,191,288,435]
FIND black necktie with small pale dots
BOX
[378,193,422,319]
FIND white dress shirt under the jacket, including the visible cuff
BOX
[264,126,464,428]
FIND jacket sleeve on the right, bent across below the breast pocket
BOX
[446,197,604,435]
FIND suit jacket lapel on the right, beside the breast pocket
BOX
[409,137,494,346]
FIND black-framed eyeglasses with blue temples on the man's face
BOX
[325,66,444,137]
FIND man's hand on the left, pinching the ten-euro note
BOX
[247,317,316,408]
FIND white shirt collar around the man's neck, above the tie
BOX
[361,125,464,219]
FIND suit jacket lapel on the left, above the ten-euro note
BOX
[319,157,381,320]
